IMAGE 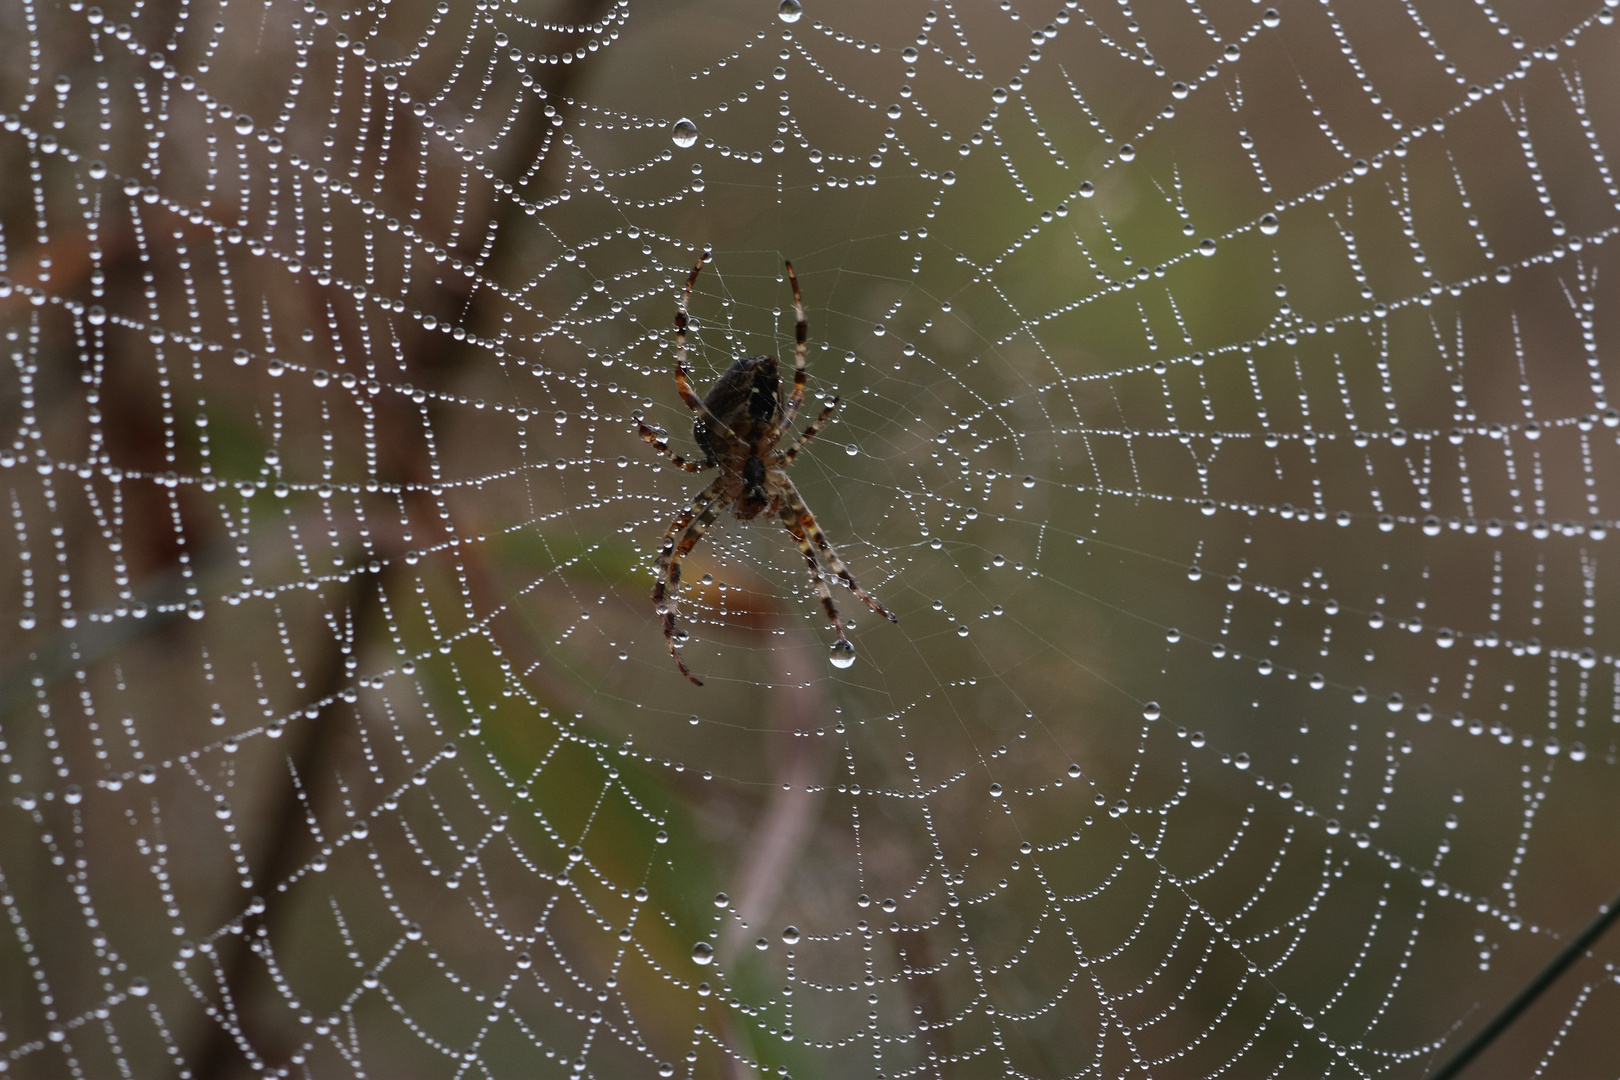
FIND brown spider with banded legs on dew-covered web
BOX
[637,251,899,687]
